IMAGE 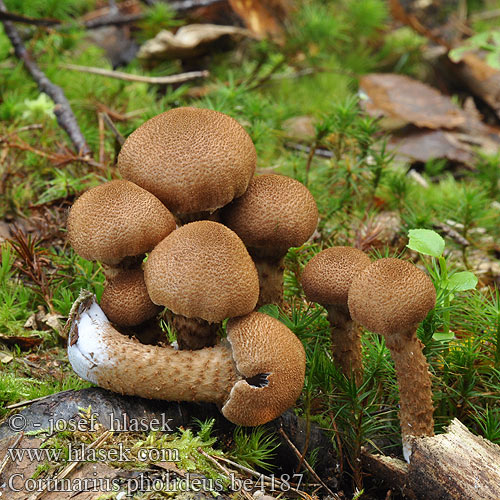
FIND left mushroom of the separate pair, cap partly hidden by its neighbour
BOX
[301,246,370,384]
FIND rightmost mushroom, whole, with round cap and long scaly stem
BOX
[348,258,436,461]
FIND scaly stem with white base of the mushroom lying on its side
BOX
[68,292,243,405]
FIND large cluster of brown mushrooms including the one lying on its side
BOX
[68,107,318,425]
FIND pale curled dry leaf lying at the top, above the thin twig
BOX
[137,24,253,59]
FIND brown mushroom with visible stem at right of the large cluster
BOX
[221,174,318,306]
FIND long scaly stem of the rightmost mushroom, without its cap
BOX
[384,327,434,462]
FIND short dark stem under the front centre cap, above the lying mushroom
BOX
[167,311,220,351]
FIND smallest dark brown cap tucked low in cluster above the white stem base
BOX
[101,269,161,326]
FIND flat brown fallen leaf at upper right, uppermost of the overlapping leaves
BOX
[360,73,466,129]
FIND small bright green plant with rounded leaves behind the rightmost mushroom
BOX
[407,229,477,341]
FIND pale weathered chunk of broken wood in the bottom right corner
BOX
[408,419,500,500]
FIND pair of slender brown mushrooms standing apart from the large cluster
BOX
[302,247,436,461]
